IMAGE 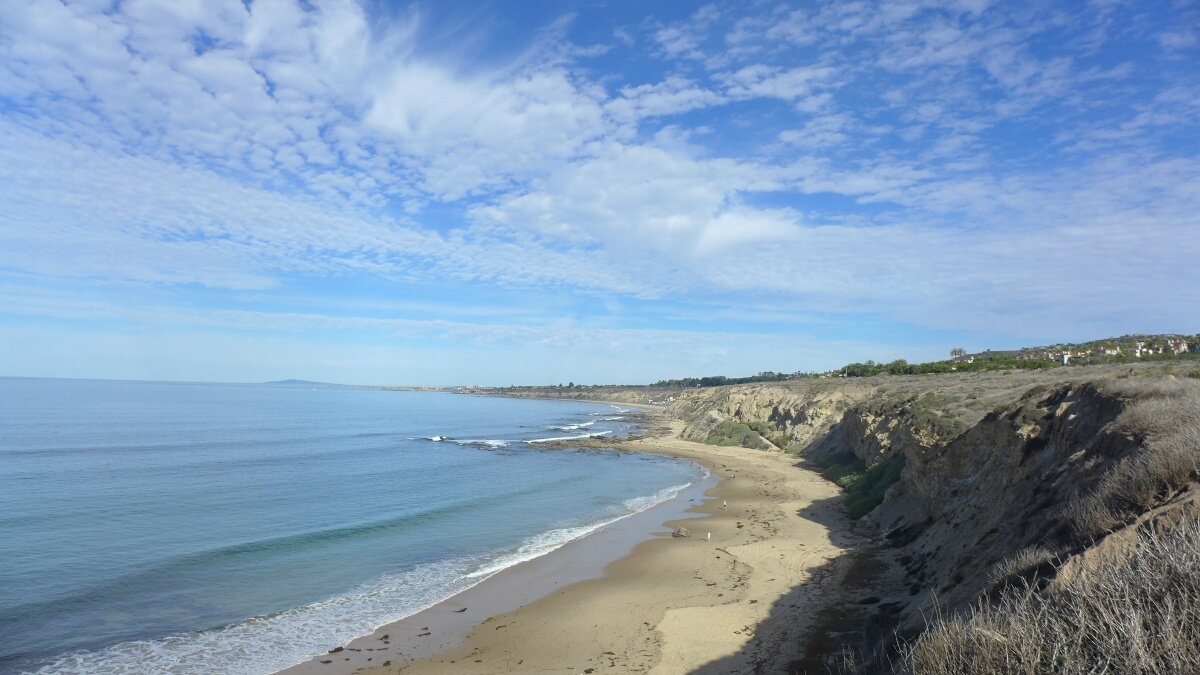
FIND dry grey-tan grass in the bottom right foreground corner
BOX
[898,520,1200,675]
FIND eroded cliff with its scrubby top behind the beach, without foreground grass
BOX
[667,365,1200,673]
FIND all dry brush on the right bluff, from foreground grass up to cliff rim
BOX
[900,371,1200,675]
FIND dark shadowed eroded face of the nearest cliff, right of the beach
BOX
[864,383,1141,631]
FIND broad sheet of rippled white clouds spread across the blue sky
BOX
[0,0,1200,362]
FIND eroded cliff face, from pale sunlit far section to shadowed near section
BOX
[671,381,1141,600]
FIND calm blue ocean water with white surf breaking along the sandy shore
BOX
[0,378,703,674]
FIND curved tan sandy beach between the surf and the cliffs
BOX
[284,417,860,675]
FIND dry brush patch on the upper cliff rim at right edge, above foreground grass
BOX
[1064,380,1200,542]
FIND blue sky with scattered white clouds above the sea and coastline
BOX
[0,0,1200,386]
